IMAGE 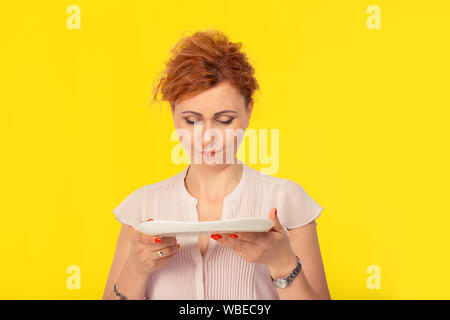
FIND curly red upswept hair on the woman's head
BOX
[152,30,259,109]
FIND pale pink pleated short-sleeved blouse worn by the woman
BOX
[113,160,323,300]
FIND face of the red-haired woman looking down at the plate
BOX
[172,81,253,166]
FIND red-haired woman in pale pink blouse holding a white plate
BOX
[103,31,330,300]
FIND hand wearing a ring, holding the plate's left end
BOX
[127,231,180,274]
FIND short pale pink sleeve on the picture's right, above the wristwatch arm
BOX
[277,180,323,229]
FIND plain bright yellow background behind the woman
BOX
[0,0,450,299]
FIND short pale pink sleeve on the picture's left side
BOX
[113,188,145,229]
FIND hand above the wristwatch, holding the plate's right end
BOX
[211,208,296,270]
